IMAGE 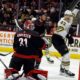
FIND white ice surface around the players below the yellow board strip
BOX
[0,52,79,80]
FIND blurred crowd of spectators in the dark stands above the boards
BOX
[0,0,79,35]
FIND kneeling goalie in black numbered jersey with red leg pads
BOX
[5,19,47,80]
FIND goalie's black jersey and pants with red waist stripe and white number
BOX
[9,30,45,74]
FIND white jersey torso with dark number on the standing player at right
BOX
[55,17,73,38]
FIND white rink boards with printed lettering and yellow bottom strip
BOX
[0,31,80,59]
